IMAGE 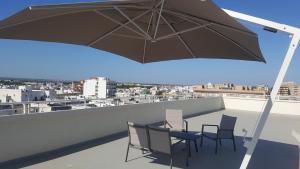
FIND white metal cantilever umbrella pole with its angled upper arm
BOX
[223,9,300,169]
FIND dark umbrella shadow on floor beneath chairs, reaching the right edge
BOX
[144,137,299,169]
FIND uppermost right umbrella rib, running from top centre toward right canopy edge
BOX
[164,9,256,37]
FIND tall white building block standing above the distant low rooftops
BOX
[83,77,116,99]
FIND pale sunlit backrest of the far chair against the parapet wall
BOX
[166,109,184,131]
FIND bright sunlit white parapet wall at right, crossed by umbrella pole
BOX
[223,96,300,116]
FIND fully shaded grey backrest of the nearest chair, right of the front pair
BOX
[148,126,172,154]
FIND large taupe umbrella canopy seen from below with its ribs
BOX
[0,0,265,63]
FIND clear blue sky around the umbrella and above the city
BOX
[0,0,300,85]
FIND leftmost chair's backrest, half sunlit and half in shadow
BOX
[127,122,149,148]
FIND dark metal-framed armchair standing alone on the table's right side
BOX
[200,115,237,154]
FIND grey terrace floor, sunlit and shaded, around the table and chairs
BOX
[0,110,300,169]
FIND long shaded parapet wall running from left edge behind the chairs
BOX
[0,97,224,163]
